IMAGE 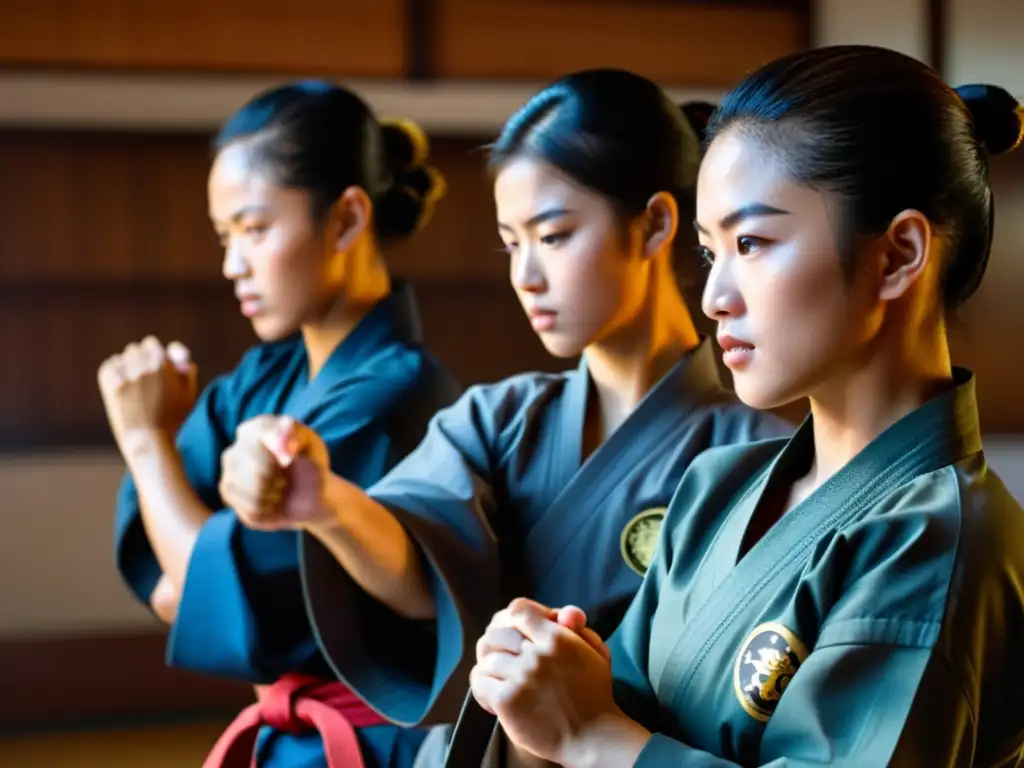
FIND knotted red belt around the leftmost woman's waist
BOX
[203,675,387,768]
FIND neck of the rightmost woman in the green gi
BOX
[808,324,952,487]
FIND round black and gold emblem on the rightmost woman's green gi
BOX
[732,622,807,723]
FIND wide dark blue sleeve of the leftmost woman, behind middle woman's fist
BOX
[168,364,428,682]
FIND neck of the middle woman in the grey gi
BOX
[585,259,700,434]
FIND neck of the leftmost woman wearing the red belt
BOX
[302,247,391,381]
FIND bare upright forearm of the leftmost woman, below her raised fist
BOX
[122,433,212,595]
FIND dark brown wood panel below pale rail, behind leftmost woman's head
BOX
[0,131,507,285]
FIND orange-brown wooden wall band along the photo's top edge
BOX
[0,0,810,86]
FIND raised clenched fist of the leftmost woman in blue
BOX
[96,336,197,454]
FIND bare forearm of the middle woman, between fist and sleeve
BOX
[307,475,435,620]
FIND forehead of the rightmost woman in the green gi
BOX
[696,130,798,228]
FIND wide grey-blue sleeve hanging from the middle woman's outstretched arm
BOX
[303,384,518,725]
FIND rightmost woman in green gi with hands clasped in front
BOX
[471,46,1024,768]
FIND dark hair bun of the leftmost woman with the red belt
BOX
[377,118,444,239]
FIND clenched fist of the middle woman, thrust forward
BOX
[219,416,332,530]
